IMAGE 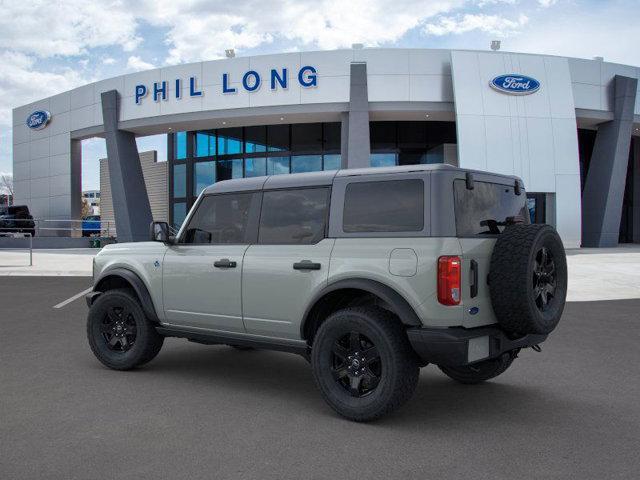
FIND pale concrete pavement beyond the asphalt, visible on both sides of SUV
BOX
[0,245,640,302]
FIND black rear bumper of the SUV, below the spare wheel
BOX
[407,326,547,367]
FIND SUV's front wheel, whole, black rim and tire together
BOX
[87,289,164,370]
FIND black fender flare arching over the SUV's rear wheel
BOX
[300,278,422,338]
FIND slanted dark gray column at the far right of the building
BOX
[582,75,638,247]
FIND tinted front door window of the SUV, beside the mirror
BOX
[182,193,254,244]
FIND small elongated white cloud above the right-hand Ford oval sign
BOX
[424,14,529,37]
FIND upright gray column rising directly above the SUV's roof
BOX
[343,63,371,168]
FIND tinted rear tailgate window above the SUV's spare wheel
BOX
[453,180,529,237]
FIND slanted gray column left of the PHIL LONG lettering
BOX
[102,90,152,242]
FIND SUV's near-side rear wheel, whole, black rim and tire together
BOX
[311,307,419,421]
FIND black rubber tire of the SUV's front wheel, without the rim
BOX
[87,289,164,370]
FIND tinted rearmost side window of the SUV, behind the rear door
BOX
[342,179,425,233]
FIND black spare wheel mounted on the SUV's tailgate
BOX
[489,224,567,335]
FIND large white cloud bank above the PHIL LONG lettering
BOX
[135,0,464,64]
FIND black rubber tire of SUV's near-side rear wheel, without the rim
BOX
[311,307,420,422]
